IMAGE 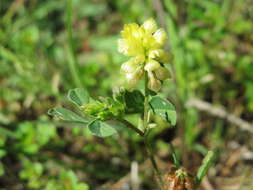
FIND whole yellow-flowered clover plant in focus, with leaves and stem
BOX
[48,19,214,190]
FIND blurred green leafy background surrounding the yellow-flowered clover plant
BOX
[0,0,253,190]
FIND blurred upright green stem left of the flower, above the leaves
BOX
[66,0,82,87]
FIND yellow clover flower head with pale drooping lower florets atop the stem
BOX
[118,18,171,92]
